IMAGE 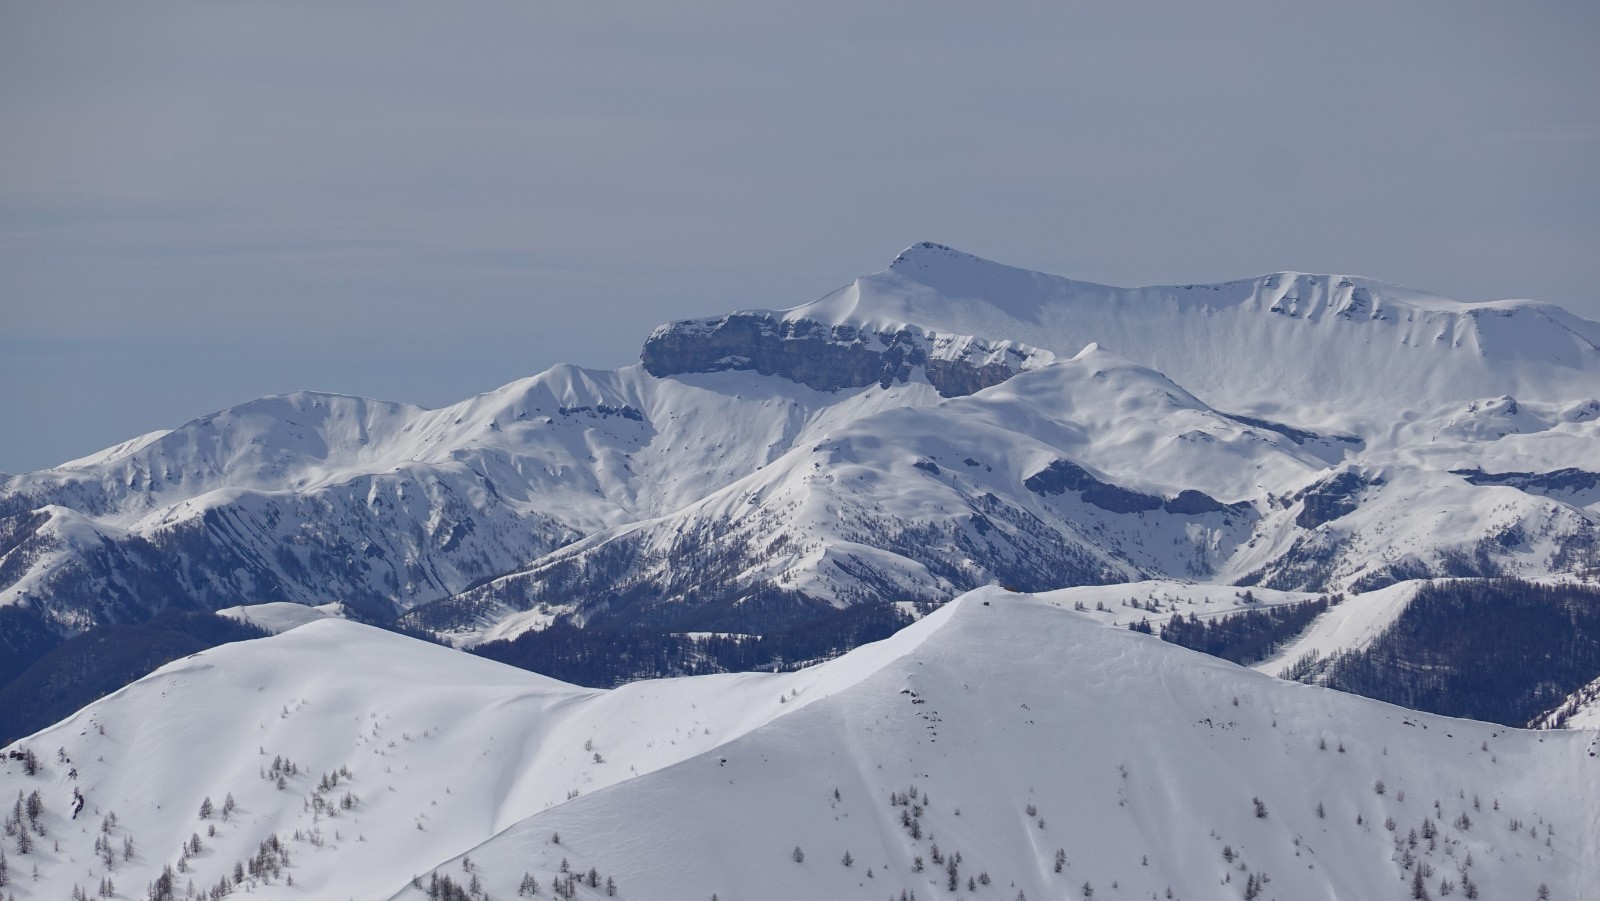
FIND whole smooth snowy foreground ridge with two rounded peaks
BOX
[0,589,1600,901]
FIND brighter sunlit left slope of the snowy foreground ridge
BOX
[0,619,934,898]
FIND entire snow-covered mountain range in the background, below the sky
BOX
[0,243,1600,643]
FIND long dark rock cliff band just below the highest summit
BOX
[640,314,1027,397]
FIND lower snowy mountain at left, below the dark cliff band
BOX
[0,366,936,627]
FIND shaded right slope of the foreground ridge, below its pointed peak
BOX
[425,591,1600,899]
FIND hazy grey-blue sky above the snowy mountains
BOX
[0,0,1600,472]
